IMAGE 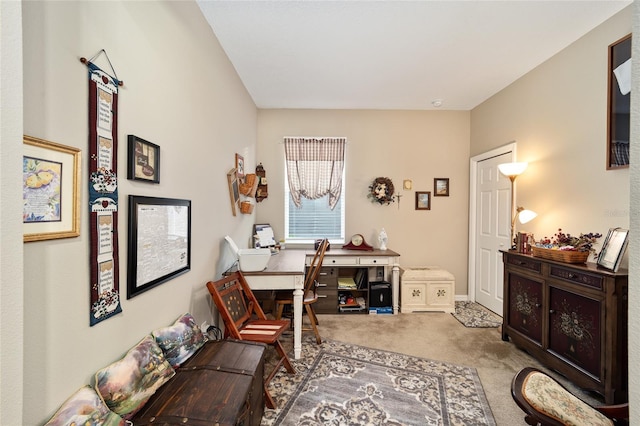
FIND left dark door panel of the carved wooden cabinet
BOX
[508,273,542,344]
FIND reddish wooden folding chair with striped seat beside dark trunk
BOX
[207,271,296,409]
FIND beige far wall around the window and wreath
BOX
[256,110,469,294]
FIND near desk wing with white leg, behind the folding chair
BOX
[242,250,306,359]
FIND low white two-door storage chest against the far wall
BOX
[400,266,456,313]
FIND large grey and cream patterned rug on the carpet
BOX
[262,336,495,426]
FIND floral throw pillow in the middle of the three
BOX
[96,335,175,419]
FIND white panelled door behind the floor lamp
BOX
[474,153,512,315]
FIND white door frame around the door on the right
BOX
[467,141,516,302]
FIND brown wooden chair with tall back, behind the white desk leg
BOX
[275,238,329,344]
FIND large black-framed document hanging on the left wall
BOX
[127,195,191,299]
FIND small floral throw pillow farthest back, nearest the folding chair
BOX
[153,313,206,368]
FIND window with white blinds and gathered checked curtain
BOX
[284,137,346,243]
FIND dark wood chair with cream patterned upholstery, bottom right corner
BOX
[511,367,629,426]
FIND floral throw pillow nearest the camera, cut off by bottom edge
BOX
[45,386,125,426]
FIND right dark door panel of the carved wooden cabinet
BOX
[549,286,602,377]
